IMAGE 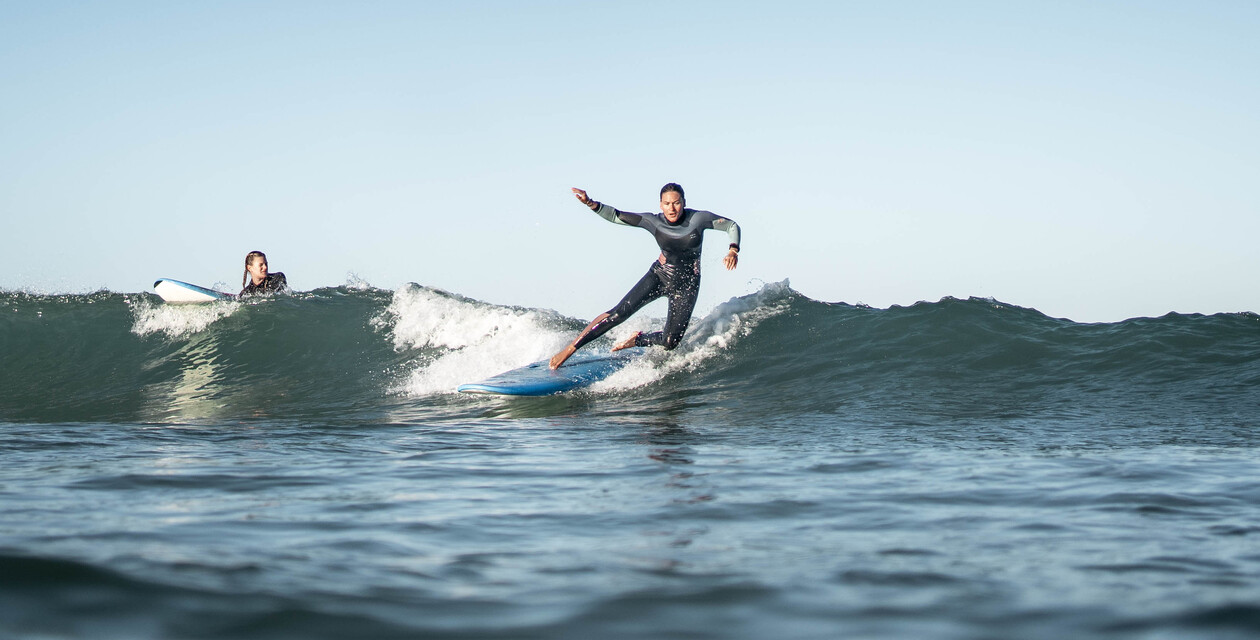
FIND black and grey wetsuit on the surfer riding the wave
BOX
[573,204,740,349]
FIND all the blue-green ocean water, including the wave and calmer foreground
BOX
[0,282,1260,639]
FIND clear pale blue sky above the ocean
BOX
[0,0,1260,323]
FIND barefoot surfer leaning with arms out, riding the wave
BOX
[551,183,740,369]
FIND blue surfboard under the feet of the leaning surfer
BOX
[455,346,648,396]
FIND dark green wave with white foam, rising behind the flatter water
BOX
[0,281,1260,423]
